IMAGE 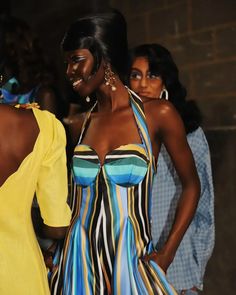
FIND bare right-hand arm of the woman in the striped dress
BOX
[145,101,200,271]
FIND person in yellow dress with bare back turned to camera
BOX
[0,103,71,295]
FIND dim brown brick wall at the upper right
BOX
[110,0,236,128]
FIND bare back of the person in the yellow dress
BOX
[0,105,39,186]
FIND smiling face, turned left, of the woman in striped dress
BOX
[65,49,104,97]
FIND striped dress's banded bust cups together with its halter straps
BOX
[72,89,154,187]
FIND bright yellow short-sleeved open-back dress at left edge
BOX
[0,109,71,295]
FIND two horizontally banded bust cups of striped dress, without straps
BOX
[72,144,149,187]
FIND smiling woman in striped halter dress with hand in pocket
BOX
[50,11,199,295]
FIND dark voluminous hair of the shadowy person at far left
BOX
[0,16,56,89]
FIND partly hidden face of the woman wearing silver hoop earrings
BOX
[129,57,164,98]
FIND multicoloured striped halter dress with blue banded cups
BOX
[51,92,177,295]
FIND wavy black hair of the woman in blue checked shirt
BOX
[128,44,202,133]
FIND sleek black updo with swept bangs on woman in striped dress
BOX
[61,10,128,80]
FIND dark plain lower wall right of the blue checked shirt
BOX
[202,131,236,295]
